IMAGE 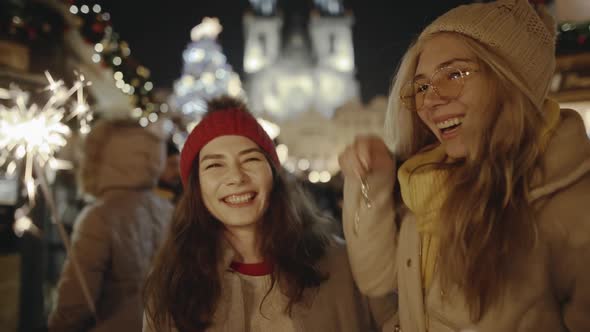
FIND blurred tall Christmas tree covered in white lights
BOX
[170,17,243,120]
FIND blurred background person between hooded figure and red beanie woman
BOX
[156,139,182,203]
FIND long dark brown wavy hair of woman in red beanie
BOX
[143,98,330,331]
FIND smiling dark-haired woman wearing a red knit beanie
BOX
[144,97,395,332]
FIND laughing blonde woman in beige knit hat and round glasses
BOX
[340,0,590,332]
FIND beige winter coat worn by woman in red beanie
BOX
[143,246,396,332]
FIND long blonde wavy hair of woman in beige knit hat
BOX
[385,33,544,321]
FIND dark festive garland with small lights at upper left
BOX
[0,0,160,119]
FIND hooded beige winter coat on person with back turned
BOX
[48,124,172,332]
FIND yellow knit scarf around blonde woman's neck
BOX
[398,100,560,289]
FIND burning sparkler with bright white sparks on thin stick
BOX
[0,72,98,320]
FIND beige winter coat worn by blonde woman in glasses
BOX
[343,110,590,332]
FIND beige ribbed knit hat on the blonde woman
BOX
[419,0,555,109]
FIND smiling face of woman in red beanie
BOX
[199,136,273,231]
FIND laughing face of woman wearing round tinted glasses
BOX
[414,34,492,158]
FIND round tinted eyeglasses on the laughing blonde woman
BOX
[400,67,477,111]
